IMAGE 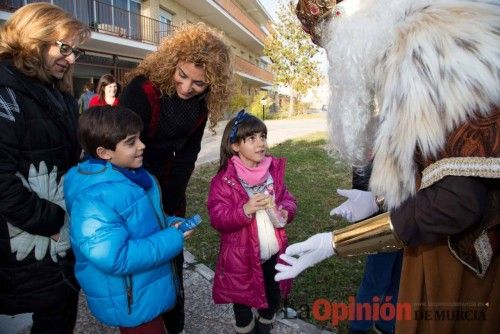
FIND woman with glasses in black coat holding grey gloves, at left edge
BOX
[0,2,90,334]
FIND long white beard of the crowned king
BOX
[323,0,400,166]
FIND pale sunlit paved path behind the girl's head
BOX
[196,114,326,166]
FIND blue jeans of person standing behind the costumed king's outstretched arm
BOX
[349,251,403,333]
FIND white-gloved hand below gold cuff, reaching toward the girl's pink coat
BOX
[274,232,335,281]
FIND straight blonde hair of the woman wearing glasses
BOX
[0,2,90,92]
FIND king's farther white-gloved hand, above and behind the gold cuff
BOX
[330,189,379,223]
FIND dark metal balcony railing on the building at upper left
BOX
[0,0,174,44]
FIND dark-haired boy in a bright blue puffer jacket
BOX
[64,106,184,334]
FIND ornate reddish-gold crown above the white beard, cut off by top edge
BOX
[295,0,342,46]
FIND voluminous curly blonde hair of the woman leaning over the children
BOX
[125,22,234,131]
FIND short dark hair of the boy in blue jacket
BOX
[77,105,142,158]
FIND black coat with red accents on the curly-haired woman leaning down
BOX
[120,76,208,216]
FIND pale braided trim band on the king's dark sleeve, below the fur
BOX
[420,157,500,189]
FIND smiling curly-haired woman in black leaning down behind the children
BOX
[120,23,233,334]
